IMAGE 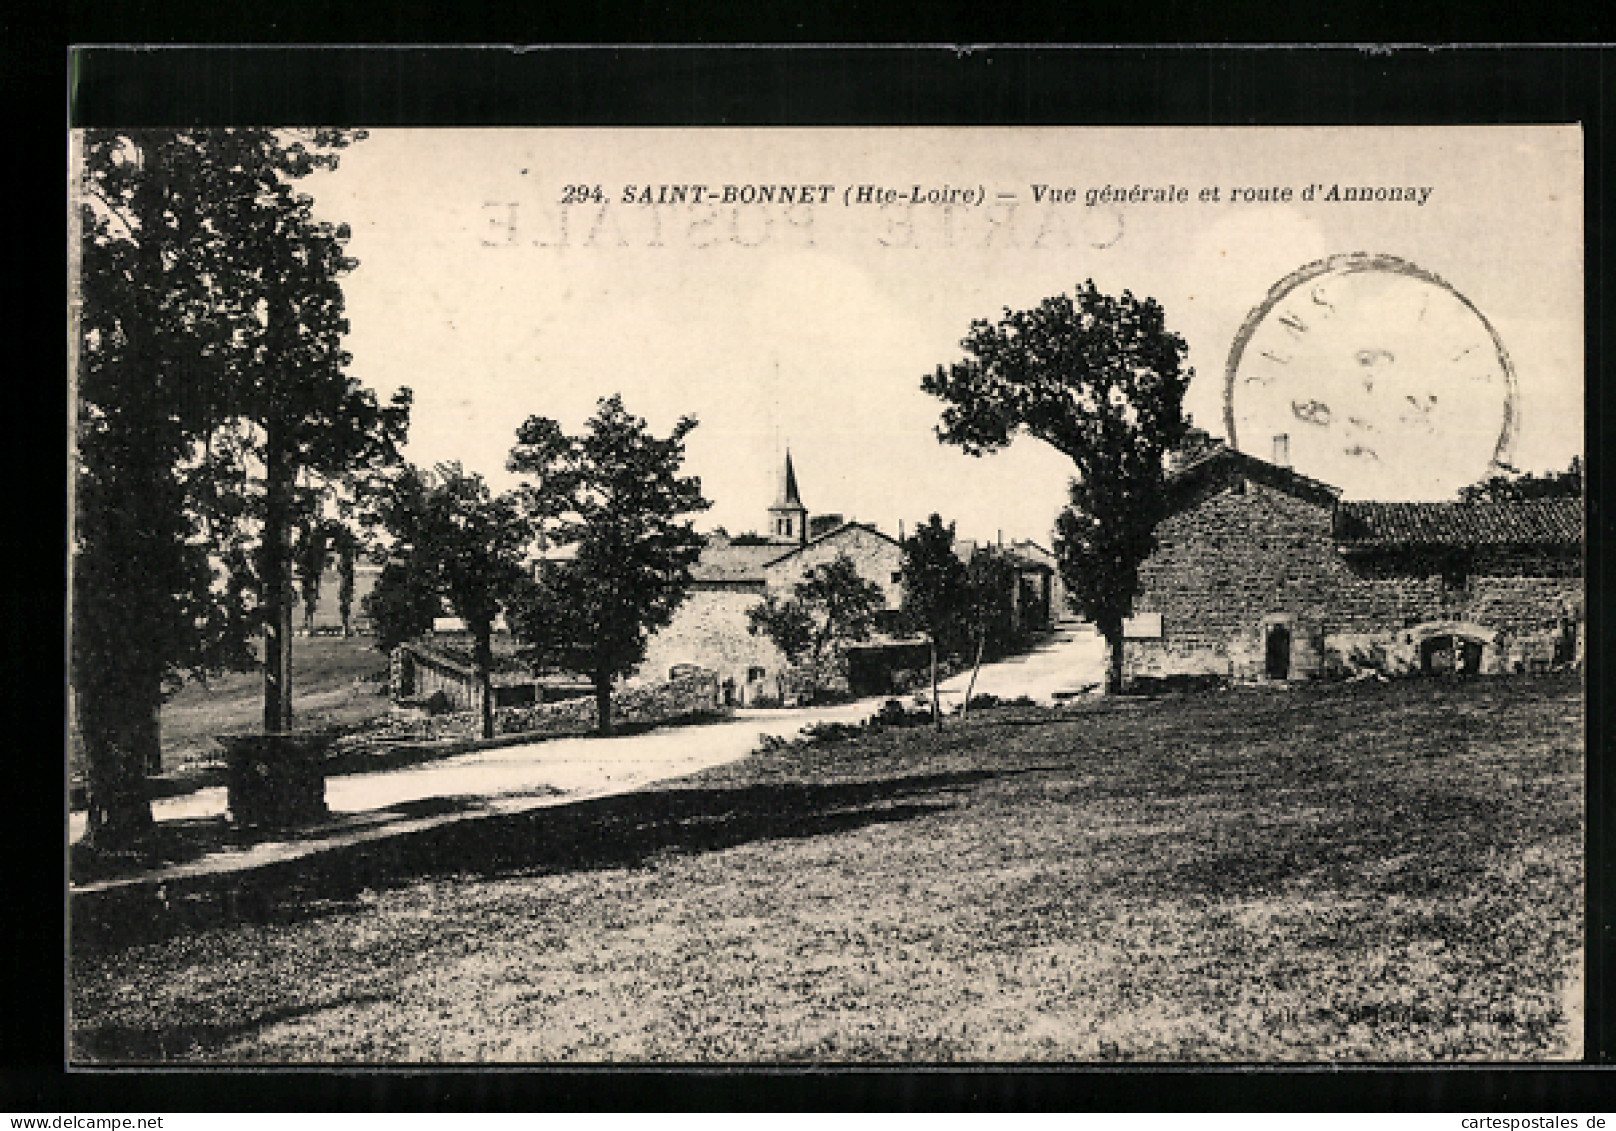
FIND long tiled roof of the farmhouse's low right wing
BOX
[1335,499,1582,548]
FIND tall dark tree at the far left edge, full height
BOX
[71,131,244,847]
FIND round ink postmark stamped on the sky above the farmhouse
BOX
[1223,252,1521,499]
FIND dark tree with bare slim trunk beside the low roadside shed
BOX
[372,464,532,738]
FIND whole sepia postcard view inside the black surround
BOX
[65,124,1587,1068]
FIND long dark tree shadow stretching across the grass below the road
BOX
[71,771,997,961]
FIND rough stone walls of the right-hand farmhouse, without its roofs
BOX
[1125,481,1582,679]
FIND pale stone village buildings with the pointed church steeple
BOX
[637,454,903,704]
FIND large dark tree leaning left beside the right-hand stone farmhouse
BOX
[921,280,1194,692]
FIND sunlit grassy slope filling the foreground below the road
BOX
[71,677,1584,1063]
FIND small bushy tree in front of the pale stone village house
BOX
[747,554,886,692]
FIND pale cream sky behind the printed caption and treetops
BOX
[304,126,1582,544]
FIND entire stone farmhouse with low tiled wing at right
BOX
[1123,443,1582,680]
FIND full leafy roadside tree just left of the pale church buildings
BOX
[507,396,711,734]
